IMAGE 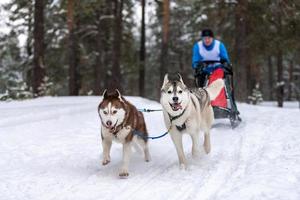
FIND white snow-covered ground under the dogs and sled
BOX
[0,97,300,200]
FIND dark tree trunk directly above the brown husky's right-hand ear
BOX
[110,0,123,91]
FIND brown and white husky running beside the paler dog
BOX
[98,90,150,178]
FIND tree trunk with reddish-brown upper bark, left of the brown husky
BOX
[67,0,79,96]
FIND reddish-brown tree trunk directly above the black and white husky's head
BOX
[160,0,170,84]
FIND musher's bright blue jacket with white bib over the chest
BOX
[192,39,230,69]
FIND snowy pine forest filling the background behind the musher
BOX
[0,0,300,107]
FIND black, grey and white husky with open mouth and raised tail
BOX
[160,74,224,168]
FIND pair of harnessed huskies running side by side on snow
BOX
[98,74,224,178]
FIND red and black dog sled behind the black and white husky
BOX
[195,60,242,128]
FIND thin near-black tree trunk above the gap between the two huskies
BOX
[139,0,146,97]
